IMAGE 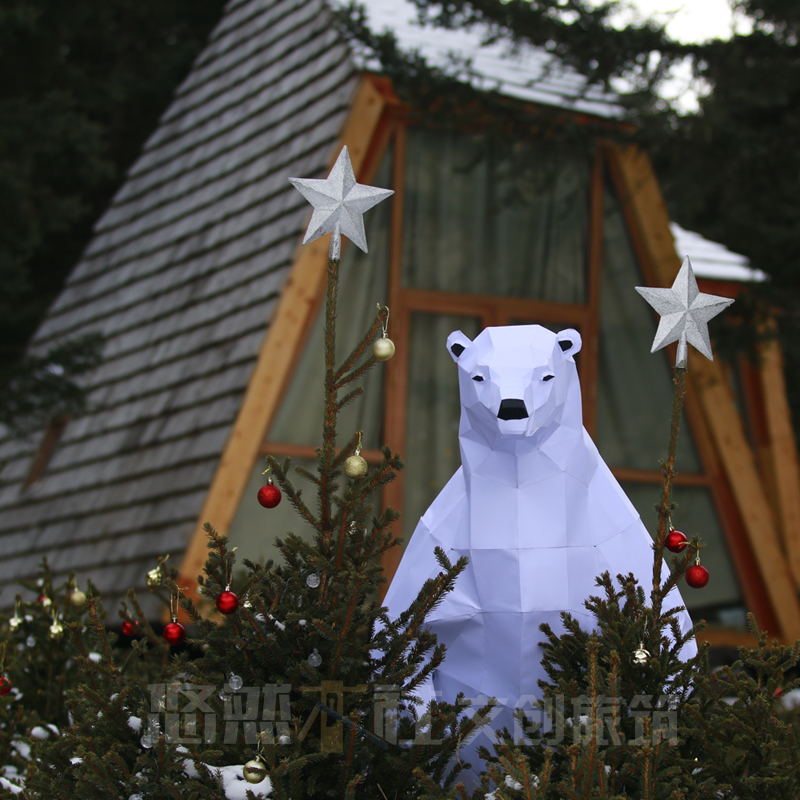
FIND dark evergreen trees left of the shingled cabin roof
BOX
[0,0,224,431]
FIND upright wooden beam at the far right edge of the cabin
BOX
[758,328,800,589]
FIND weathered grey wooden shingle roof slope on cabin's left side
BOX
[0,0,357,606]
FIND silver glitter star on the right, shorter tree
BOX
[636,256,733,367]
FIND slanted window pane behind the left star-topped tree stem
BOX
[267,148,392,448]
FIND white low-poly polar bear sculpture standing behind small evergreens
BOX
[384,325,696,767]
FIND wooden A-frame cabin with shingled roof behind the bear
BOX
[0,0,800,645]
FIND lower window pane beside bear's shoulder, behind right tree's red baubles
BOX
[622,482,746,628]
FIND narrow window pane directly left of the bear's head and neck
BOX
[403,312,481,542]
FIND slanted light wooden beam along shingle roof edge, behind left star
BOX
[180,78,394,593]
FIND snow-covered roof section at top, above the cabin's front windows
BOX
[344,0,623,118]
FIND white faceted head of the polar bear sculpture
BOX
[447,325,582,437]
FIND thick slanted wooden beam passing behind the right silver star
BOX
[609,146,800,643]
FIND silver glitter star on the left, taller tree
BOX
[289,146,394,261]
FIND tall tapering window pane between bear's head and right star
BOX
[597,186,701,472]
